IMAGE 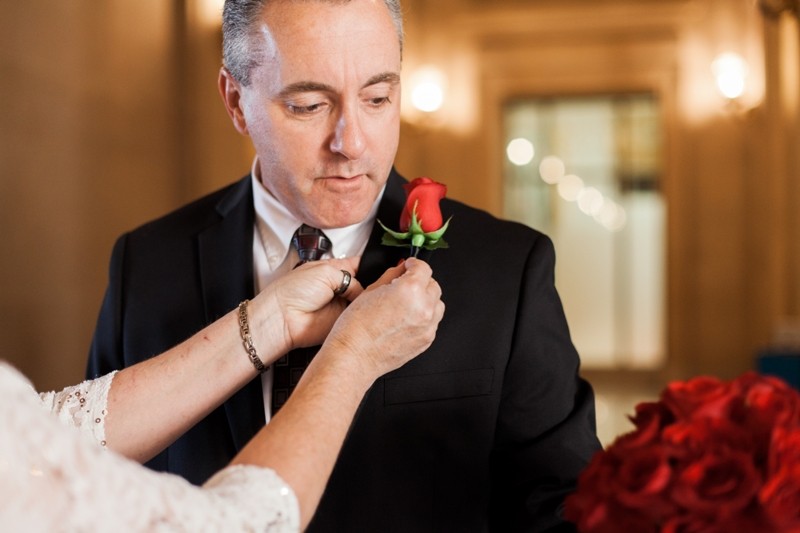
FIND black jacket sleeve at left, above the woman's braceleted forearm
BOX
[86,235,127,379]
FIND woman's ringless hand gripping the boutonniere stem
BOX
[325,258,444,379]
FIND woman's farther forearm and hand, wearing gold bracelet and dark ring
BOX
[105,258,362,462]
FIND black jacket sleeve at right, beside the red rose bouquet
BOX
[491,236,600,531]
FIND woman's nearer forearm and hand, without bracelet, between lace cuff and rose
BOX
[232,259,444,528]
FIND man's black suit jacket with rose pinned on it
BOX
[88,171,599,533]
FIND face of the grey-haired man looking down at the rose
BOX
[231,0,400,229]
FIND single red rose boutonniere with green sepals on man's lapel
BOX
[378,177,450,257]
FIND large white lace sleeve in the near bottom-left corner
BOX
[0,361,300,532]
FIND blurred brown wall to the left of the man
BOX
[0,0,249,388]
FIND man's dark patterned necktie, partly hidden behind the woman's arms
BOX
[272,224,331,415]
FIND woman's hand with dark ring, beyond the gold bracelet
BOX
[250,257,364,356]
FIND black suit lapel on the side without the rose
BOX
[197,176,265,450]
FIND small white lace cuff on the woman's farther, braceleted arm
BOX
[39,371,117,446]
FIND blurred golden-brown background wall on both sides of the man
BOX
[0,0,800,440]
